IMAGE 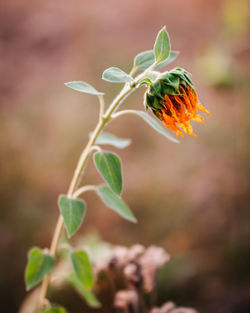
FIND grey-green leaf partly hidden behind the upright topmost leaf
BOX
[134,50,179,70]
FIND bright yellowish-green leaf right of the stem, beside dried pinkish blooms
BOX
[71,250,94,289]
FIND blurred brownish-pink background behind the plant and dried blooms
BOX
[0,0,250,313]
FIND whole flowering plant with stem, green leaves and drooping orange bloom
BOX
[25,27,208,313]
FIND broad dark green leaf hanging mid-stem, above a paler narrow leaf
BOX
[94,151,122,195]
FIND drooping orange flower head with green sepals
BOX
[146,68,210,138]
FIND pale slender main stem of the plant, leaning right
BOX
[38,84,134,313]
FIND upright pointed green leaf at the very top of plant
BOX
[154,26,170,64]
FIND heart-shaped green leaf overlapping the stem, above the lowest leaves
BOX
[58,195,86,237]
